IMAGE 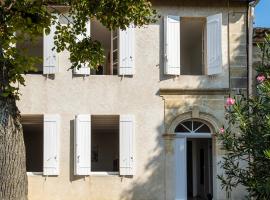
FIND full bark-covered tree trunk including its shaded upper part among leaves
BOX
[0,10,28,200]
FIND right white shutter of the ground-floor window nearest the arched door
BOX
[119,115,135,176]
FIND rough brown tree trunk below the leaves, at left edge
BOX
[0,97,28,200]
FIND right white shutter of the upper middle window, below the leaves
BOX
[118,25,135,75]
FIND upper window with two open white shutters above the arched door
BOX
[164,14,222,75]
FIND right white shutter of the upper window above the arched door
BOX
[207,14,222,75]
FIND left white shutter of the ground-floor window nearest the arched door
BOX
[74,115,91,175]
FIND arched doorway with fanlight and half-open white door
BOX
[174,119,213,200]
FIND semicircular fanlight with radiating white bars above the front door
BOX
[174,120,211,134]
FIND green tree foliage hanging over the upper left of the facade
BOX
[0,0,156,98]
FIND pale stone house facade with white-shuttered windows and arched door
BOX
[18,0,258,200]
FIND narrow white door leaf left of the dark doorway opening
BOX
[175,137,187,200]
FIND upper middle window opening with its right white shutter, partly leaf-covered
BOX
[91,19,135,76]
